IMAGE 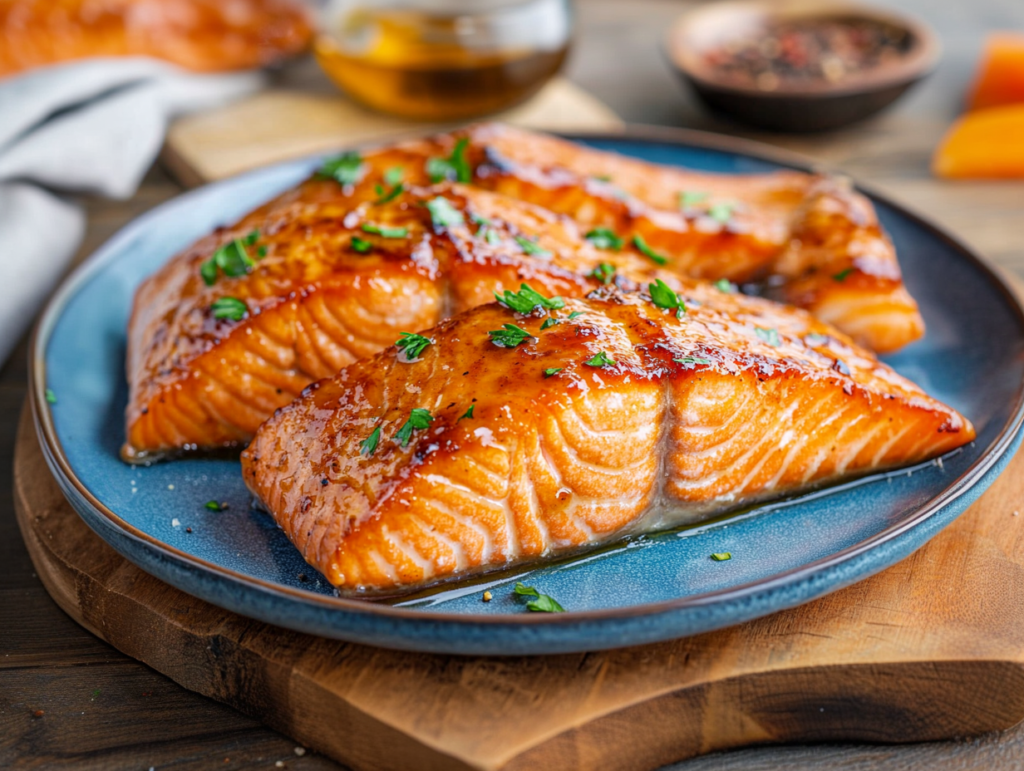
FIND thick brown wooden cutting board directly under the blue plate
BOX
[14,399,1024,771]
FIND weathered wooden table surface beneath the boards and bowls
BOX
[0,0,1024,771]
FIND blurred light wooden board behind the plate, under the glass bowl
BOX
[162,78,623,186]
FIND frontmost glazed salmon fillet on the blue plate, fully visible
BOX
[242,284,975,593]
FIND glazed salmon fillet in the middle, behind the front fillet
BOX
[122,180,672,463]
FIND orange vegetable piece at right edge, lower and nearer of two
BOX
[932,102,1024,179]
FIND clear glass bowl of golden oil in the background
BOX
[315,0,571,121]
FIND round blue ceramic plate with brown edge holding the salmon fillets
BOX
[32,127,1024,654]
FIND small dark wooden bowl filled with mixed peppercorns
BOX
[667,0,939,131]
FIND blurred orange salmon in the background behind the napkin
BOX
[0,0,312,78]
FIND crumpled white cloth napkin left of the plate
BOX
[0,58,263,365]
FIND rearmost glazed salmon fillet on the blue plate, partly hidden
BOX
[348,124,925,353]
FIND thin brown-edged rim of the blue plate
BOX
[29,124,1024,629]
